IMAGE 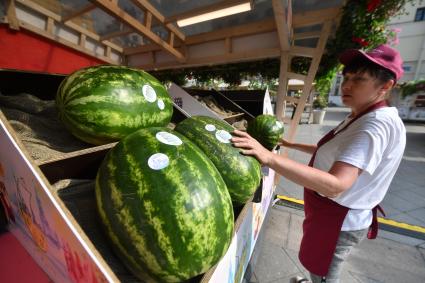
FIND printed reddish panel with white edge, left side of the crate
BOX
[0,117,115,282]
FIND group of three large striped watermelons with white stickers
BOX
[56,66,261,282]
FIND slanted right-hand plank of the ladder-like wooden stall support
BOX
[287,20,332,141]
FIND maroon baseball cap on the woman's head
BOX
[339,44,404,81]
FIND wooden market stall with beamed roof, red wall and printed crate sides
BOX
[0,0,343,282]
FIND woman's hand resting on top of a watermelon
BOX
[231,130,273,165]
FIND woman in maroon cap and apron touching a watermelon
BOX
[232,45,406,283]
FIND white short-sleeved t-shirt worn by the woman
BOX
[313,107,406,231]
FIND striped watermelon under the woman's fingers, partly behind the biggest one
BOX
[175,116,261,204]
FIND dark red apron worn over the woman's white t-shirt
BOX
[299,101,387,276]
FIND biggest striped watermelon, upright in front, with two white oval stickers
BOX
[96,127,234,282]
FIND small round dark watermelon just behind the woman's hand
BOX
[246,114,284,150]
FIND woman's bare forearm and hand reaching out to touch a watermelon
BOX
[232,131,361,197]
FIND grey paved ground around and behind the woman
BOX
[247,108,425,283]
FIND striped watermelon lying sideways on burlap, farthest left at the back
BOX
[56,65,173,144]
